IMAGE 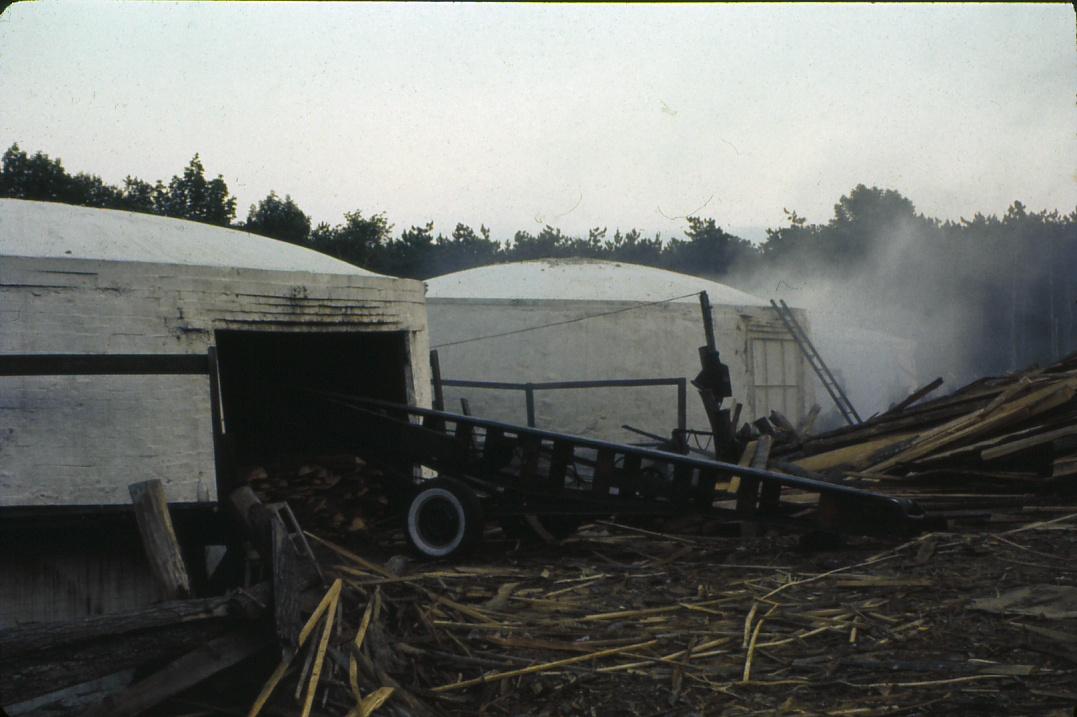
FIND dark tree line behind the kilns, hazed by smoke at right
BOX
[0,144,1077,371]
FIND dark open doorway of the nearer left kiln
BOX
[216,331,408,465]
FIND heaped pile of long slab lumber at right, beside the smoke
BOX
[755,354,1077,523]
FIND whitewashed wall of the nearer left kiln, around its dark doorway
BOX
[0,256,430,506]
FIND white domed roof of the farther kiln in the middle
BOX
[426,259,769,306]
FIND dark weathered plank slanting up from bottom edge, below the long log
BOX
[84,629,272,717]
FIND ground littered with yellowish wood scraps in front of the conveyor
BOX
[233,514,1077,715]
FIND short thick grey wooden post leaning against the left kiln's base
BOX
[127,479,191,600]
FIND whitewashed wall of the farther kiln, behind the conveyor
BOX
[426,298,805,441]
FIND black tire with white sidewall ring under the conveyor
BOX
[404,476,482,560]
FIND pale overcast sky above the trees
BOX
[0,2,1077,243]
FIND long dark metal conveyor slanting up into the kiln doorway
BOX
[308,392,923,537]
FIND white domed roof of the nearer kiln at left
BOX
[0,199,380,277]
